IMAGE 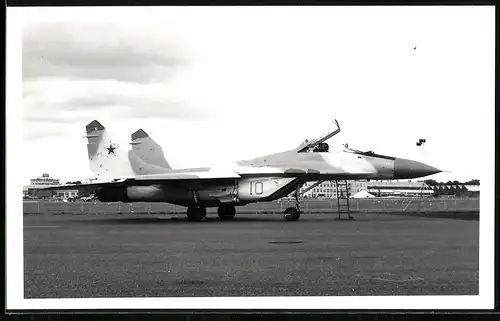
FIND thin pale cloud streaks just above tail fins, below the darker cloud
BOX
[23,78,210,132]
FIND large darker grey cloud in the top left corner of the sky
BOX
[22,22,187,83]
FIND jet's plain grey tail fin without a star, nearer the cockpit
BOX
[129,129,172,175]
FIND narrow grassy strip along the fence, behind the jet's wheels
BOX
[23,198,479,219]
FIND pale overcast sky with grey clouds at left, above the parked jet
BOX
[22,6,494,184]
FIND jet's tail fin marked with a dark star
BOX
[85,120,134,178]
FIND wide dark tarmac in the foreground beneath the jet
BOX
[24,198,479,298]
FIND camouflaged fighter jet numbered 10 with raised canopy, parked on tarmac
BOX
[47,120,441,221]
